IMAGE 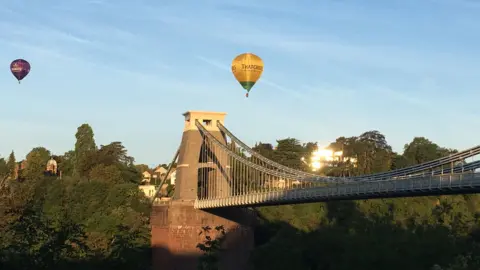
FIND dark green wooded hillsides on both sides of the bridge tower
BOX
[0,127,480,270]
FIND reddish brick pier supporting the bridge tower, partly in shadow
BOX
[151,202,254,270]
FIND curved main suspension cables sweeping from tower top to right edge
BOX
[217,121,480,181]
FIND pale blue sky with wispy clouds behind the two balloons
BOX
[0,0,480,164]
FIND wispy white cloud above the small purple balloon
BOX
[0,9,171,76]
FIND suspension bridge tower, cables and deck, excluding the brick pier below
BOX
[155,112,480,209]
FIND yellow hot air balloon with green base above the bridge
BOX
[232,53,263,97]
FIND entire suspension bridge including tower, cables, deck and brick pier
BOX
[150,111,480,270]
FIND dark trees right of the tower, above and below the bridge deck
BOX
[252,131,480,270]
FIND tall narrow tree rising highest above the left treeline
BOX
[74,124,97,177]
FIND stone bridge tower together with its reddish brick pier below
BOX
[150,111,255,270]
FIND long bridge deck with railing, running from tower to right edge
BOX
[195,172,480,209]
